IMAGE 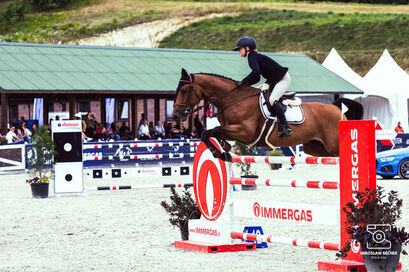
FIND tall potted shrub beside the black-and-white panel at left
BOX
[26,126,56,198]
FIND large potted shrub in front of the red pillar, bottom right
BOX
[337,186,409,272]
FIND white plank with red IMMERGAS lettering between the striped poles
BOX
[234,199,339,226]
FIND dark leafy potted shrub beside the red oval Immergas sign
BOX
[160,187,201,240]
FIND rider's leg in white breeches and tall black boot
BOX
[269,72,293,137]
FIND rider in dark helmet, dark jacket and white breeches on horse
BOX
[233,37,293,137]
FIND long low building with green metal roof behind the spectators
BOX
[0,43,362,135]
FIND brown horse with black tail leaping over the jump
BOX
[172,69,363,161]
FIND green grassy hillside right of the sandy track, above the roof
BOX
[160,10,409,74]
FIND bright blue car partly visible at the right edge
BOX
[376,148,409,179]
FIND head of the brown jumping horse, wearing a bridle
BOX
[172,69,202,122]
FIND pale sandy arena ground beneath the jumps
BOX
[0,165,409,272]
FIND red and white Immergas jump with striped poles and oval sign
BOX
[175,121,386,272]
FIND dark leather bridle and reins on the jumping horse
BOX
[173,74,261,119]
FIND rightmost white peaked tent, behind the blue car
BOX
[362,49,409,131]
